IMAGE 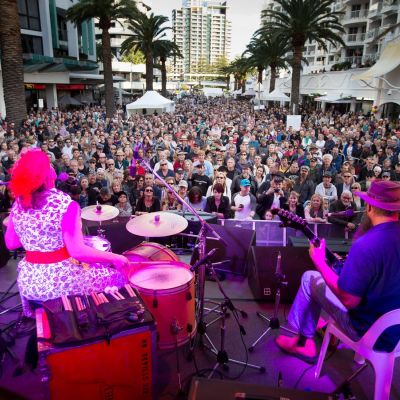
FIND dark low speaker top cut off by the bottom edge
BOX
[189,377,333,400]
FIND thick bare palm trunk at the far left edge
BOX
[0,0,26,127]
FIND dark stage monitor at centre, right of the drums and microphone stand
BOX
[206,224,256,276]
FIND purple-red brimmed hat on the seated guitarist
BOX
[354,180,400,211]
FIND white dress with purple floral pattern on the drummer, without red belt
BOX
[11,189,126,316]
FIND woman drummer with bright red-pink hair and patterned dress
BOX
[5,150,128,317]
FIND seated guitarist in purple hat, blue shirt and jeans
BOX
[276,180,400,363]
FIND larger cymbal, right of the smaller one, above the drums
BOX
[126,211,188,237]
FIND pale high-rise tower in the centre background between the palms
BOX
[172,0,232,80]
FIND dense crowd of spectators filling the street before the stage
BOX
[0,96,400,230]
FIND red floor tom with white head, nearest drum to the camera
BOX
[128,262,196,349]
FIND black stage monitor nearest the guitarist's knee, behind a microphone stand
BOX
[248,246,314,302]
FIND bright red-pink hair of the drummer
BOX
[10,149,51,208]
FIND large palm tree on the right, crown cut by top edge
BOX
[257,0,345,114]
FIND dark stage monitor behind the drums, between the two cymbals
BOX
[85,217,145,254]
